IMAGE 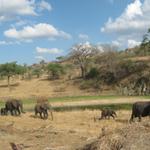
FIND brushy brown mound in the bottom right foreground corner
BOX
[76,122,150,150]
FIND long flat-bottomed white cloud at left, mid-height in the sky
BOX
[4,23,71,40]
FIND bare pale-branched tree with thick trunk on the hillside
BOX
[69,43,98,78]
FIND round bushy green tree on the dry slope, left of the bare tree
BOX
[47,63,65,79]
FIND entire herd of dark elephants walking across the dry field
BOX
[0,99,150,122]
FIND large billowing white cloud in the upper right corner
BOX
[101,0,150,45]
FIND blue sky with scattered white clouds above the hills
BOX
[0,0,150,64]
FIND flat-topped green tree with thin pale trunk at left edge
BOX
[0,62,23,87]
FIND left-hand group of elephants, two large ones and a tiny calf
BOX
[0,99,53,120]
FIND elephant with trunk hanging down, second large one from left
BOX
[34,103,53,120]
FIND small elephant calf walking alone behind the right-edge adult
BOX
[99,109,117,119]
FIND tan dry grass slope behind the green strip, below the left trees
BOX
[0,78,95,98]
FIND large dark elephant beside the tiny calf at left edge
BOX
[5,99,24,115]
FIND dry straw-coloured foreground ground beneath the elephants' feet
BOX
[0,110,130,150]
